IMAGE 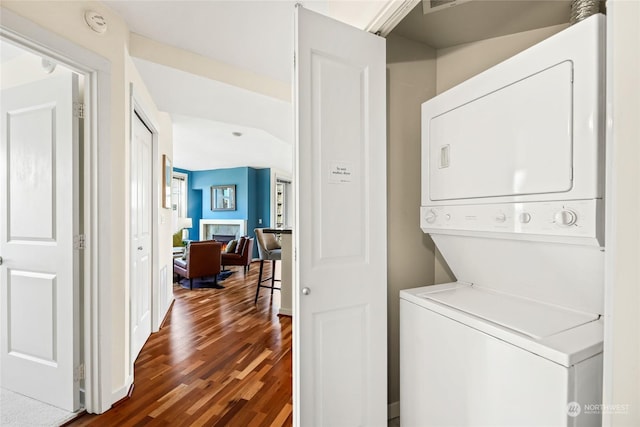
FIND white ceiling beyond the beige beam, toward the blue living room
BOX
[134,59,293,172]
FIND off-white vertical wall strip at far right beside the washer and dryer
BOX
[603,0,640,427]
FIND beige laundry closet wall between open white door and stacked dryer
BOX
[387,35,436,416]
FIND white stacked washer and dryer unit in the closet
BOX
[400,15,605,426]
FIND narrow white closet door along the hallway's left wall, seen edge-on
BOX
[130,114,153,364]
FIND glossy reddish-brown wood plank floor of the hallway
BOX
[71,263,292,427]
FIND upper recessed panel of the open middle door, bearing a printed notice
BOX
[310,51,369,267]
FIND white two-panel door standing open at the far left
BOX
[0,70,80,411]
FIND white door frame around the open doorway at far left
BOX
[0,8,111,413]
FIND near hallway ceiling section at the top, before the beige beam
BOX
[104,0,294,81]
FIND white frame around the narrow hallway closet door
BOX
[128,83,162,384]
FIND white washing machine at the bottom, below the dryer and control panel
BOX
[400,283,603,426]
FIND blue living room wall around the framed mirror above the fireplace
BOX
[174,167,271,258]
